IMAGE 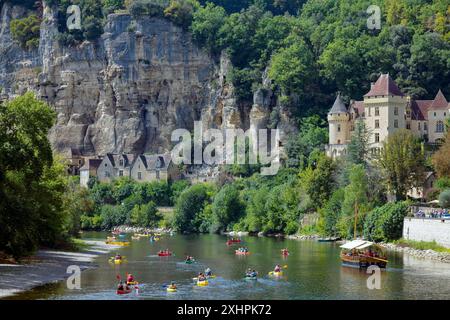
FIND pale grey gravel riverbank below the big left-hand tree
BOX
[0,240,120,299]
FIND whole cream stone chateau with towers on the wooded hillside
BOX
[326,74,450,158]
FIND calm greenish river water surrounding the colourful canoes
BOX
[6,232,450,300]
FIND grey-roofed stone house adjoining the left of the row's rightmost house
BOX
[97,153,135,182]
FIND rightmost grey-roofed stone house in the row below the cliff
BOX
[131,153,179,182]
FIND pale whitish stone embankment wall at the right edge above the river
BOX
[403,218,450,248]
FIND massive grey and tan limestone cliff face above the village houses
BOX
[0,4,249,155]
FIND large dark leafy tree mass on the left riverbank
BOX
[0,93,74,258]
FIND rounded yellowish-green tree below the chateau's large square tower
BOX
[378,129,425,200]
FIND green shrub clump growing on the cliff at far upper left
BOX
[10,14,41,49]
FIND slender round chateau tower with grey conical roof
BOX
[327,94,350,158]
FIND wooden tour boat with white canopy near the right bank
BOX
[340,240,388,268]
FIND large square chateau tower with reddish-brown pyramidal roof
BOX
[364,74,408,154]
